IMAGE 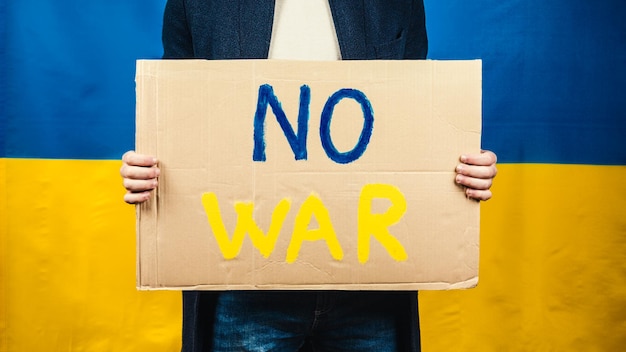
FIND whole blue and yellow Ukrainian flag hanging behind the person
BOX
[0,0,626,352]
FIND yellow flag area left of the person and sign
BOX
[0,159,182,352]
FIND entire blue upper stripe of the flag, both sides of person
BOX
[0,0,626,165]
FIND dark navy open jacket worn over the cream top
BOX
[158,0,428,352]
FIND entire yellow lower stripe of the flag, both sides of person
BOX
[0,159,626,352]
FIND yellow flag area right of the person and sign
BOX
[420,164,626,351]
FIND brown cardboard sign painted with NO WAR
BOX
[136,60,481,290]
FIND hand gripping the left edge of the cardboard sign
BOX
[120,150,161,204]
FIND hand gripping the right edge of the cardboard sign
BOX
[455,150,498,200]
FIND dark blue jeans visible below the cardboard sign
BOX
[213,291,408,352]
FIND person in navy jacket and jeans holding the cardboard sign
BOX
[120,0,497,352]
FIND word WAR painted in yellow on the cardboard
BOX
[202,184,408,264]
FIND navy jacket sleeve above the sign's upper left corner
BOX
[162,0,194,59]
